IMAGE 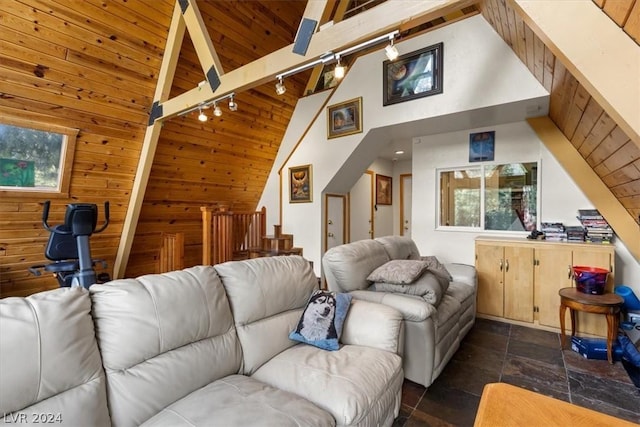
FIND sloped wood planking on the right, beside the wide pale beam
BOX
[480,0,640,227]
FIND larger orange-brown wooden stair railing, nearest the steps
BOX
[200,206,267,265]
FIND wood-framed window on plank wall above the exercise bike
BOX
[0,118,78,197]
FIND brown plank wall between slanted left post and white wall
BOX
[125,1,309,277]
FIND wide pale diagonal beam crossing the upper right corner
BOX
[509,0,640,147]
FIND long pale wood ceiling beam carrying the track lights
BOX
[157,0,477,120]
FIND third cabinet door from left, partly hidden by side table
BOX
[534,246,573,328]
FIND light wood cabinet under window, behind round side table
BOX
[476,237,615,336]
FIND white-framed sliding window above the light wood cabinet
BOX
[438,162,538,231]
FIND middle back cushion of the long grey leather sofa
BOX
[90,266,242,426]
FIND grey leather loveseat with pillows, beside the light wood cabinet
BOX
[322,236,477,387]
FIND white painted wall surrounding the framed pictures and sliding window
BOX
[261,15,640,295]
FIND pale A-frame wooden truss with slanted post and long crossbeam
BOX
[113,0,475,278]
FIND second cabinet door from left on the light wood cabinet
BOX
[504,246,533,323]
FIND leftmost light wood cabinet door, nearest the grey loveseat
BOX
[476,245,504,317]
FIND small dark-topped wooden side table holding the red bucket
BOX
[558,288,624,363]
